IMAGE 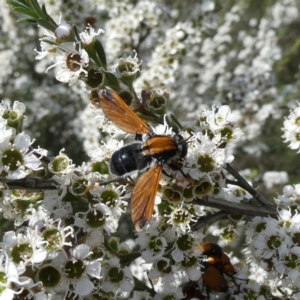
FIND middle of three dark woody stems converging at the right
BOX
[191,196,277,218]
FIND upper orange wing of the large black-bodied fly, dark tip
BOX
[98,89,151,134]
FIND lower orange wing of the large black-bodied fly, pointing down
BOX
[131,164,163,231]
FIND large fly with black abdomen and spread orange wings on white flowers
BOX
[98,89,187,231]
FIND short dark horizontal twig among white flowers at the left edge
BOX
[0,177,59,190]
